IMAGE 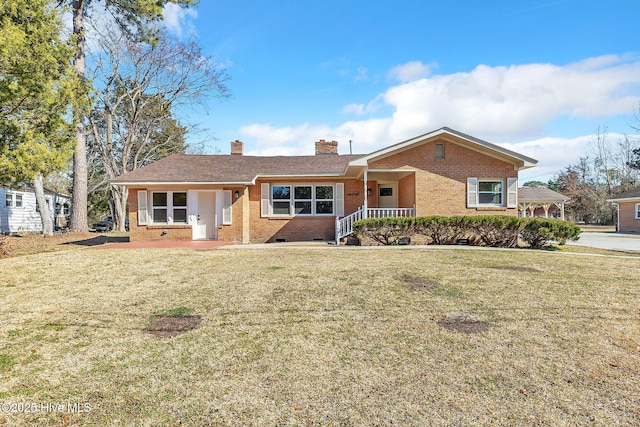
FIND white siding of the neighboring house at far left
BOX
[0,187,69,234]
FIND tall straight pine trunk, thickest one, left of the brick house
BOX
[69,0,89,232]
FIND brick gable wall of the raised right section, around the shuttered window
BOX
[369,139,518,216]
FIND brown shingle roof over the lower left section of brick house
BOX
[112,154,362,184]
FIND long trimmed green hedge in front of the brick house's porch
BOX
[353,215,580,248]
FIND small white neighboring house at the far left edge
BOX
[0,185,71,234]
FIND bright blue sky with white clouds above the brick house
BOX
[160,0,640,180]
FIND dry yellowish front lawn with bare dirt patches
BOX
[0,247,640,426]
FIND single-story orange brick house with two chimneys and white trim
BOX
[112,127,537,243]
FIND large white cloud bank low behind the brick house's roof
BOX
[235,55,640,171]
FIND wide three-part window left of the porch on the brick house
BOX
[270,185,335,216]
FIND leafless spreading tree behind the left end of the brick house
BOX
[89,28,229,230]
